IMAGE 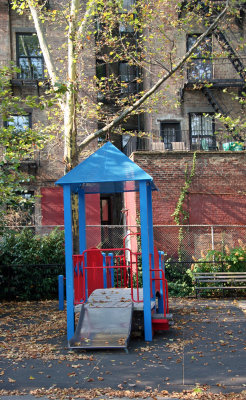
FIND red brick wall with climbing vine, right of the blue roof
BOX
[134,152,246,225]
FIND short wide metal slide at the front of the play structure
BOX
[69,289,133,349]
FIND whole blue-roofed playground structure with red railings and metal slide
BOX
[56,142,170,348]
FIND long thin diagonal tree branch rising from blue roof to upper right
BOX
[78,4,228,153]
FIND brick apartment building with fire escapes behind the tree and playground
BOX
[0,0,246,241]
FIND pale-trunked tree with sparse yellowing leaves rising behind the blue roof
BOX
[8,0,234,171]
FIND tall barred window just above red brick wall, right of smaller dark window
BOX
[190,113,216,150]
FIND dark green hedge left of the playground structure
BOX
[0,229,65,300]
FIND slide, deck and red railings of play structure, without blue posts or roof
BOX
[69,238,170,348]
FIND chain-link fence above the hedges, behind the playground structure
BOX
[1,225,246,262]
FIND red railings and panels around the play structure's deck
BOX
[73,247,168,316]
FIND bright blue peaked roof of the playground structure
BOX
[56,142,156,193]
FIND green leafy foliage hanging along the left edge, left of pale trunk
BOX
[0,66,46,220]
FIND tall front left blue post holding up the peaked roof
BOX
[63,185,74,340]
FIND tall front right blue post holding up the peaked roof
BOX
[139,181,152,341]
